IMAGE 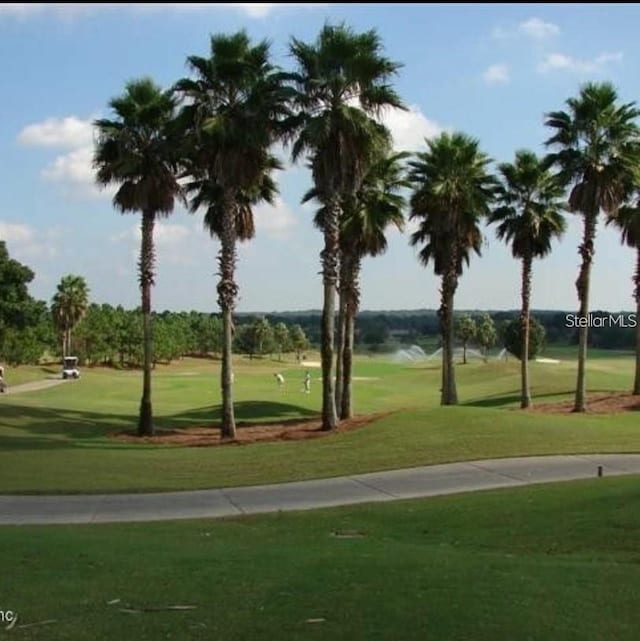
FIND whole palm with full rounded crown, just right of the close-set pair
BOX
[409,133,496,405]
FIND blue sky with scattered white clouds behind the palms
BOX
[0,4,640,312]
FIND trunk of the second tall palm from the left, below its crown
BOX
[218,193,238,439]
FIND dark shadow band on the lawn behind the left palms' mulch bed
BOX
[0,401,318,452]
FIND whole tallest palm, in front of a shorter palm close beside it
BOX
[290,25,402,430]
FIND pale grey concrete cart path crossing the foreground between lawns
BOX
[0,454,640,525]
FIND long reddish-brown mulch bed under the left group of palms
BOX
[111,412,392,447]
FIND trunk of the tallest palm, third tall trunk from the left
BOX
[320,196,342,431]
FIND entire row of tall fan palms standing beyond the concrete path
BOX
[94,24,640,438]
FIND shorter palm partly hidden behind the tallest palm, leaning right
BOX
[303,146,409,419]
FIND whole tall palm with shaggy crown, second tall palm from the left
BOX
[175,31,289,438]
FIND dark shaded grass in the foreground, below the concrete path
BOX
[0,478,640,641]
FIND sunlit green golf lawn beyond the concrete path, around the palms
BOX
[0,356,640,493]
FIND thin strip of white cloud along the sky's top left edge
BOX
[0,2,326,19]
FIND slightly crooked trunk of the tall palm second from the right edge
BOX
[573,209,598,412]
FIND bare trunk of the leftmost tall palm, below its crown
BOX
[138,211,155,436]
